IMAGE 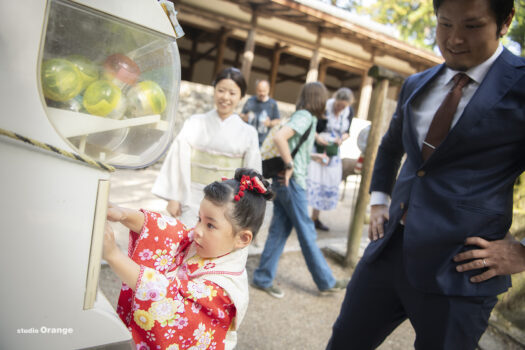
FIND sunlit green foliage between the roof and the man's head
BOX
[357,0,436,49]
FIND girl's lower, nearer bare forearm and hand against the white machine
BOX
[103,223,142,290]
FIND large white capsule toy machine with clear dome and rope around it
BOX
[0,0,182,349]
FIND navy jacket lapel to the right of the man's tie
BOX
[428,49,523,162]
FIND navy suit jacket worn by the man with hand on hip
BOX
[363,49,525,296]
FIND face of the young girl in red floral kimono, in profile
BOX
[193,198,252,259]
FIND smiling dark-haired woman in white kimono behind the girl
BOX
[152,68,261,227]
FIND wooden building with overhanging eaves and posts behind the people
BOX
[172,0,442,119]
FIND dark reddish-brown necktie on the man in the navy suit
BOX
[421,73,471,160]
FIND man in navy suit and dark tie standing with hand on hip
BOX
[328,0,525,350]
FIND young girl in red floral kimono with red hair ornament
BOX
[104,169,273,350]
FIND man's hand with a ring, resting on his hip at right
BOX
[454,233,525,283]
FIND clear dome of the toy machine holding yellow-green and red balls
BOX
[39,0,180,168]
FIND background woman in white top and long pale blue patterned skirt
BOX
[307,88,354,231]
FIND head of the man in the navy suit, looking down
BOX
[436,0,512,71]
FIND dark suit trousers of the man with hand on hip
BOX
[327,225,497,350]
